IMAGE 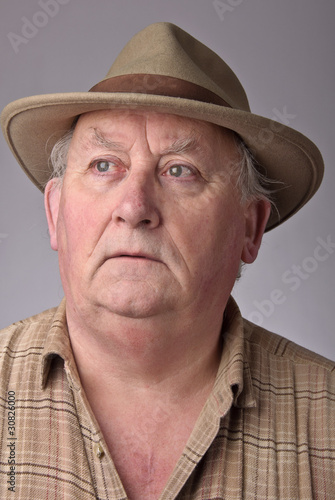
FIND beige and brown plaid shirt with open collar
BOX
[0,299,335,500]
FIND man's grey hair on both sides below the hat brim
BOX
[49,126,274,210]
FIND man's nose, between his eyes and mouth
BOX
[113,173,160,229]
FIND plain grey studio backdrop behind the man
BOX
[0,0,335,359]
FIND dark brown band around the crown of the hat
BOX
[89,74,231,108]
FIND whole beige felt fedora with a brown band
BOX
[1,23,323,230]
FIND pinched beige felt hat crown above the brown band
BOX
[101,22,250,111]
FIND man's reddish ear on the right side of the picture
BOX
[242,200,271,264]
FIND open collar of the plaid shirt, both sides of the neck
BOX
[41,297,256,410]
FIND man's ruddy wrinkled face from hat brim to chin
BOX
[46,111,270,324]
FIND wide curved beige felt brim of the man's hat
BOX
[1,92,324,231]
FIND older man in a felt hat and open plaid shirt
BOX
[1,23,335,500]
